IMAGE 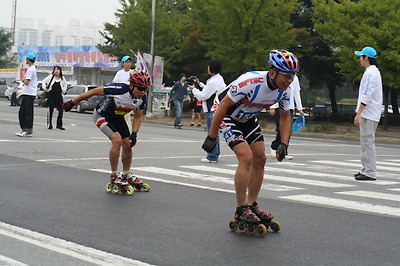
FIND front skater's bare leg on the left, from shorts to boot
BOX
[233,142,253,206]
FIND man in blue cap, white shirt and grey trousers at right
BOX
[354,46,382,181]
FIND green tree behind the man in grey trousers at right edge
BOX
[313,0,400,124]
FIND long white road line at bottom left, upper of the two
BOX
[0,222,150,265]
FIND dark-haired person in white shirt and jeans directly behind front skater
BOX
[188,59,226,163]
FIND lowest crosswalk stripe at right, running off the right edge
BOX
[278,194,400,217]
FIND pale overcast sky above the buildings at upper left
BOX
[0,0,121,28]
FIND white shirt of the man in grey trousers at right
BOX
[356,65,382,122]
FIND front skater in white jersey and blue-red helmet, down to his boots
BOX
[203,50,299,229]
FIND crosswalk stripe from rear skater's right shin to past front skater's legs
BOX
[131,167,301,191]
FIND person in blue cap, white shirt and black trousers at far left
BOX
[15,53,37,137]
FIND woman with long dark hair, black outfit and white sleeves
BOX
[42,66,67,130]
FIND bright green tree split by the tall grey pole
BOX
[99,0,194,84]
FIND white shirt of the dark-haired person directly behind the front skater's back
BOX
[192,73,226,113]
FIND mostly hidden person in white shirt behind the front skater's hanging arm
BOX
[269,76,304,160]
